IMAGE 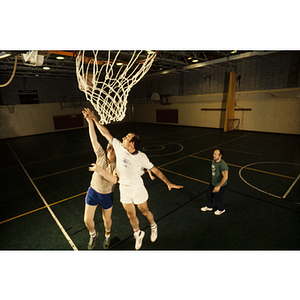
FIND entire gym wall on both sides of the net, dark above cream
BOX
[0,51,300,139]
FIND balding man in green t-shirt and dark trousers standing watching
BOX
[201,149,228,216]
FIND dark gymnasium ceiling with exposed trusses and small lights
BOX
[0,50,274,84]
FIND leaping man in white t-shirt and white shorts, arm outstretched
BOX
[85,109,183,250]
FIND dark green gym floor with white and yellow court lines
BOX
[0,124,300,252]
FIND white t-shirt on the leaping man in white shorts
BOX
[112,138,154,185]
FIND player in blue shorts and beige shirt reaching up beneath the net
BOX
[82,111,118,250]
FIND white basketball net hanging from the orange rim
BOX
[76,51,156,124]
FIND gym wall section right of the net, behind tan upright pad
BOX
[129,51,300,134]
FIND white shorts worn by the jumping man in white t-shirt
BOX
[120,184,148,204]
